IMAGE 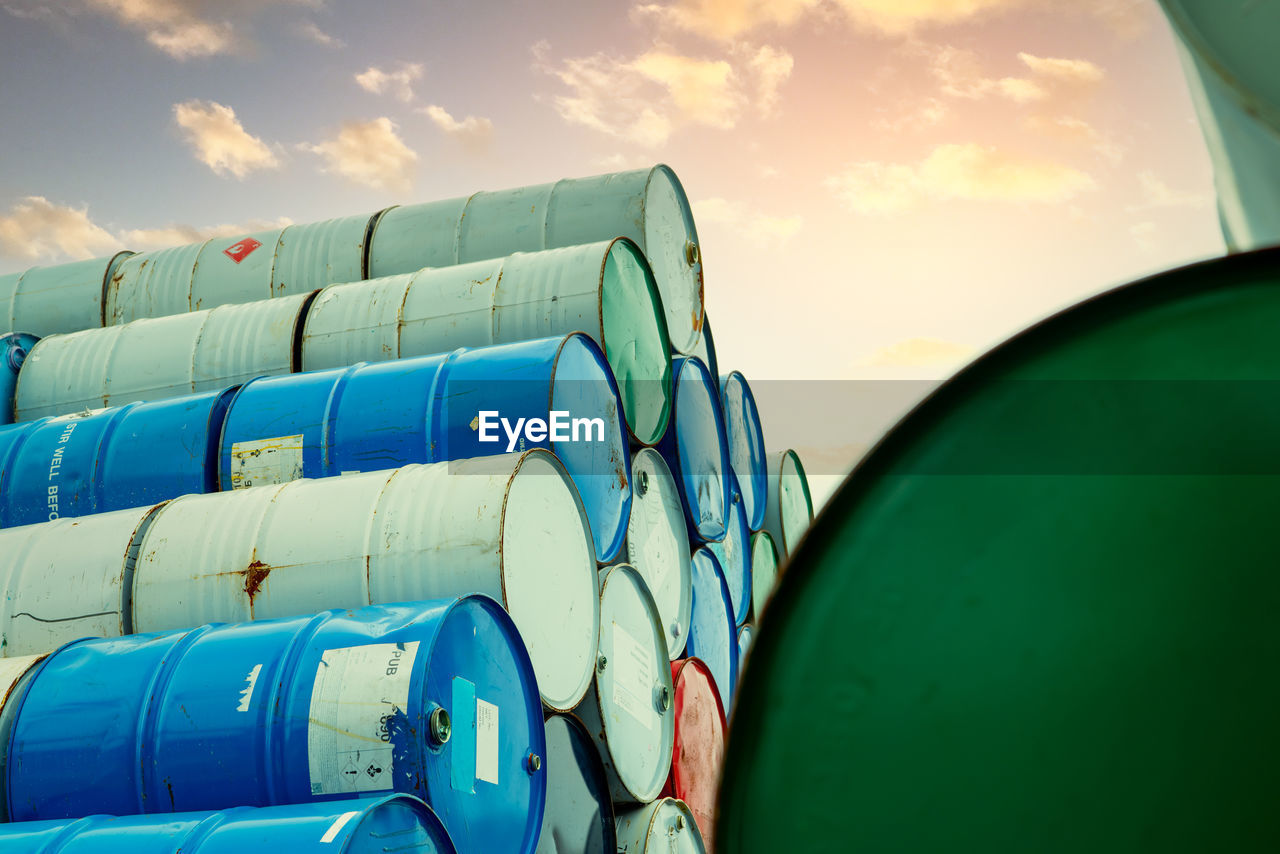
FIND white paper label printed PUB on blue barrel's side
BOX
[307,640,419,795]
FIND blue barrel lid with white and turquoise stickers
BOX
[417,595,547,851]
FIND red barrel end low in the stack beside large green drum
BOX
[662,658,727,851]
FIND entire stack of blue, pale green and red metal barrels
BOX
[0,166,813,854]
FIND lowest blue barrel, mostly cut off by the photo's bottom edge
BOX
[0,795,457,854]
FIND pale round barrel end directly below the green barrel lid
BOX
[626,448,694,661]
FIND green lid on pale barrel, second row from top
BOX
[600,238,671,444]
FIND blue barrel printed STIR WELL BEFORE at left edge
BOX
[0,387,236,528]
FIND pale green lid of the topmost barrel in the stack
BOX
[641,165,703,353]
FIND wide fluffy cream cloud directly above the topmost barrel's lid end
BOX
[534,42,795,147]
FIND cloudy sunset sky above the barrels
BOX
[0,0,1224,507]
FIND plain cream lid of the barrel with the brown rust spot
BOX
[499,449,600,712]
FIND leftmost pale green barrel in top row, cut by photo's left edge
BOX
[0,252,133,337]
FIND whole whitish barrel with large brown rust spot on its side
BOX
[133,449,599,711]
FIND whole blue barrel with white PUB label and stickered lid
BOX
[10,595,547,853]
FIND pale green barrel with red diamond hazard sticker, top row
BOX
[104,214,374,326]
